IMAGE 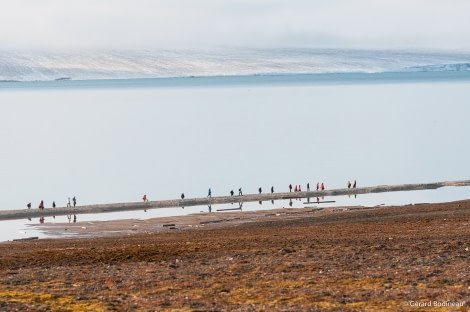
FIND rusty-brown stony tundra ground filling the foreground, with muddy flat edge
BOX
[0,200,470,311]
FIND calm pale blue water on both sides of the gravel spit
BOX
[0,72,470,239]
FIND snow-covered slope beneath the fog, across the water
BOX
[0,49,470,81]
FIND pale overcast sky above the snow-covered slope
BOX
[0,0,470,50]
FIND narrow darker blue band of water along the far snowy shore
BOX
[0,70,470,89]
